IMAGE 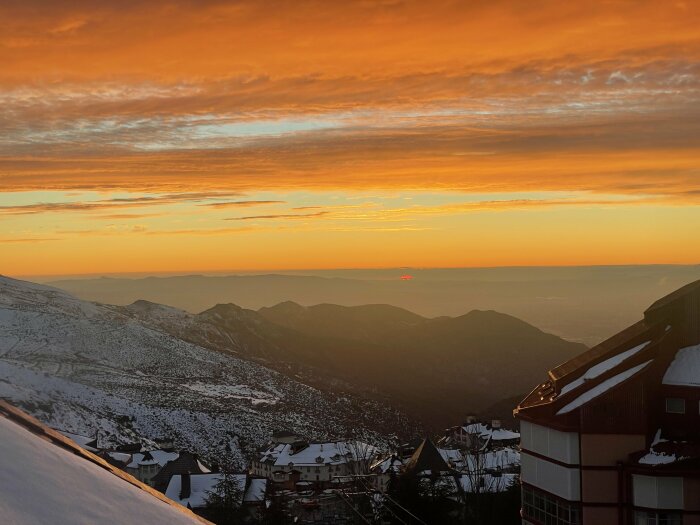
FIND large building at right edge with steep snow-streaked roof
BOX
[515,281,700,525]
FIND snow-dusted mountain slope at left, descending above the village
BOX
[0,276,404,457]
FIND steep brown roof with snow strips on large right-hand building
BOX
[515,281,700,422]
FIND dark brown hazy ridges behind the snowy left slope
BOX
[123,301,586,425]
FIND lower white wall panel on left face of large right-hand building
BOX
[520,451,581,501]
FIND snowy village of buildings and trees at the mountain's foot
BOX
[59,416,520,525]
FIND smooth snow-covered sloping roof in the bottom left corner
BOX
[0,417,201,525]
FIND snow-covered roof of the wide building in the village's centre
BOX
[260,441,377,466]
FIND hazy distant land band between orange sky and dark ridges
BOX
[49,265,700,346]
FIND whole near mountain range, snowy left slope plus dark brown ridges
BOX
[0,278,585,446]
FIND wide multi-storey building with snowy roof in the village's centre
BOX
[251,441,377,490]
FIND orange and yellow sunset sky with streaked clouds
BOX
[0,0,700,276]
